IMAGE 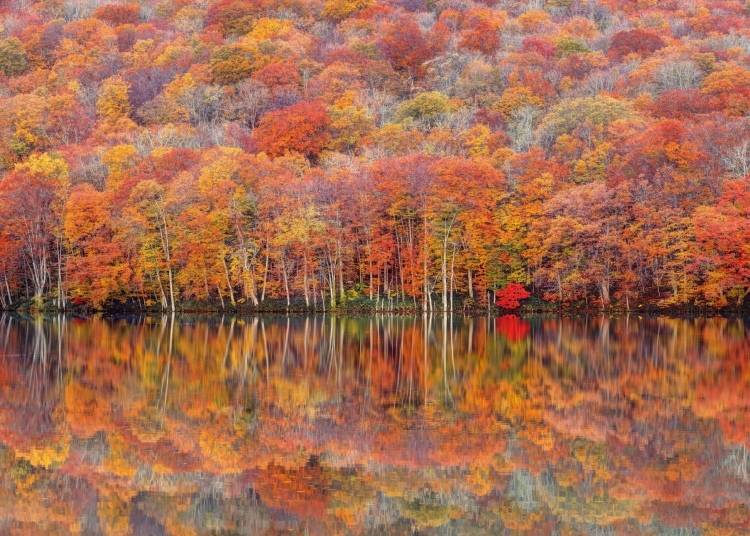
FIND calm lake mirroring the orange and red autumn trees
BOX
[0,315,750,535]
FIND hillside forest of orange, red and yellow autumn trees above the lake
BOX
[0,0,750,310]
